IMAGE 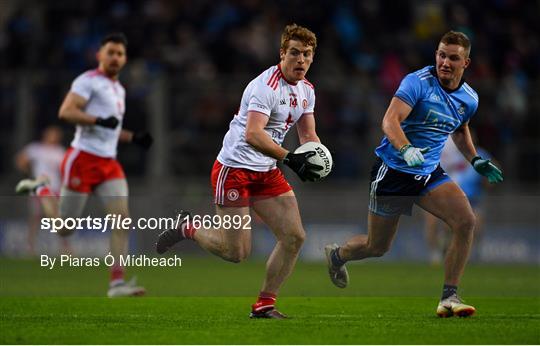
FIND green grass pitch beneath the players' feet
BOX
[0,257,540,344]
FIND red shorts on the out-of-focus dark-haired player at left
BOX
[60,148,126,193]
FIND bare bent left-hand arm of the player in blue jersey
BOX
[382,97,412,150]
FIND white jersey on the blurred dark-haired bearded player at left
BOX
[70,69,126,157]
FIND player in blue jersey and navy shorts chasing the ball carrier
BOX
[325,31,503,317]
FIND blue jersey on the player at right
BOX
[375,66,478,175]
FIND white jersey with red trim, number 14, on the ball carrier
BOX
[217,65,315,172]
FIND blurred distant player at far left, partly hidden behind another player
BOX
[15,126,69,255]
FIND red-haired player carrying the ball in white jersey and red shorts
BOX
[157,24,322,318]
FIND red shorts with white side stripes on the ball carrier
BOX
[211,160,292,207]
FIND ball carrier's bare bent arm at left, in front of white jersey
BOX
[246,111,288,161]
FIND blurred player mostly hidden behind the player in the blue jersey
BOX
[425,135,491,265]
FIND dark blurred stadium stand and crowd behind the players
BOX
[0,0,540,264]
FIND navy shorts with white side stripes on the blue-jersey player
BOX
[369,158,452,216]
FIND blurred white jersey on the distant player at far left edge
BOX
[23,142,66,191]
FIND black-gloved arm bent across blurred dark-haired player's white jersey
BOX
[58,92,119,129]
